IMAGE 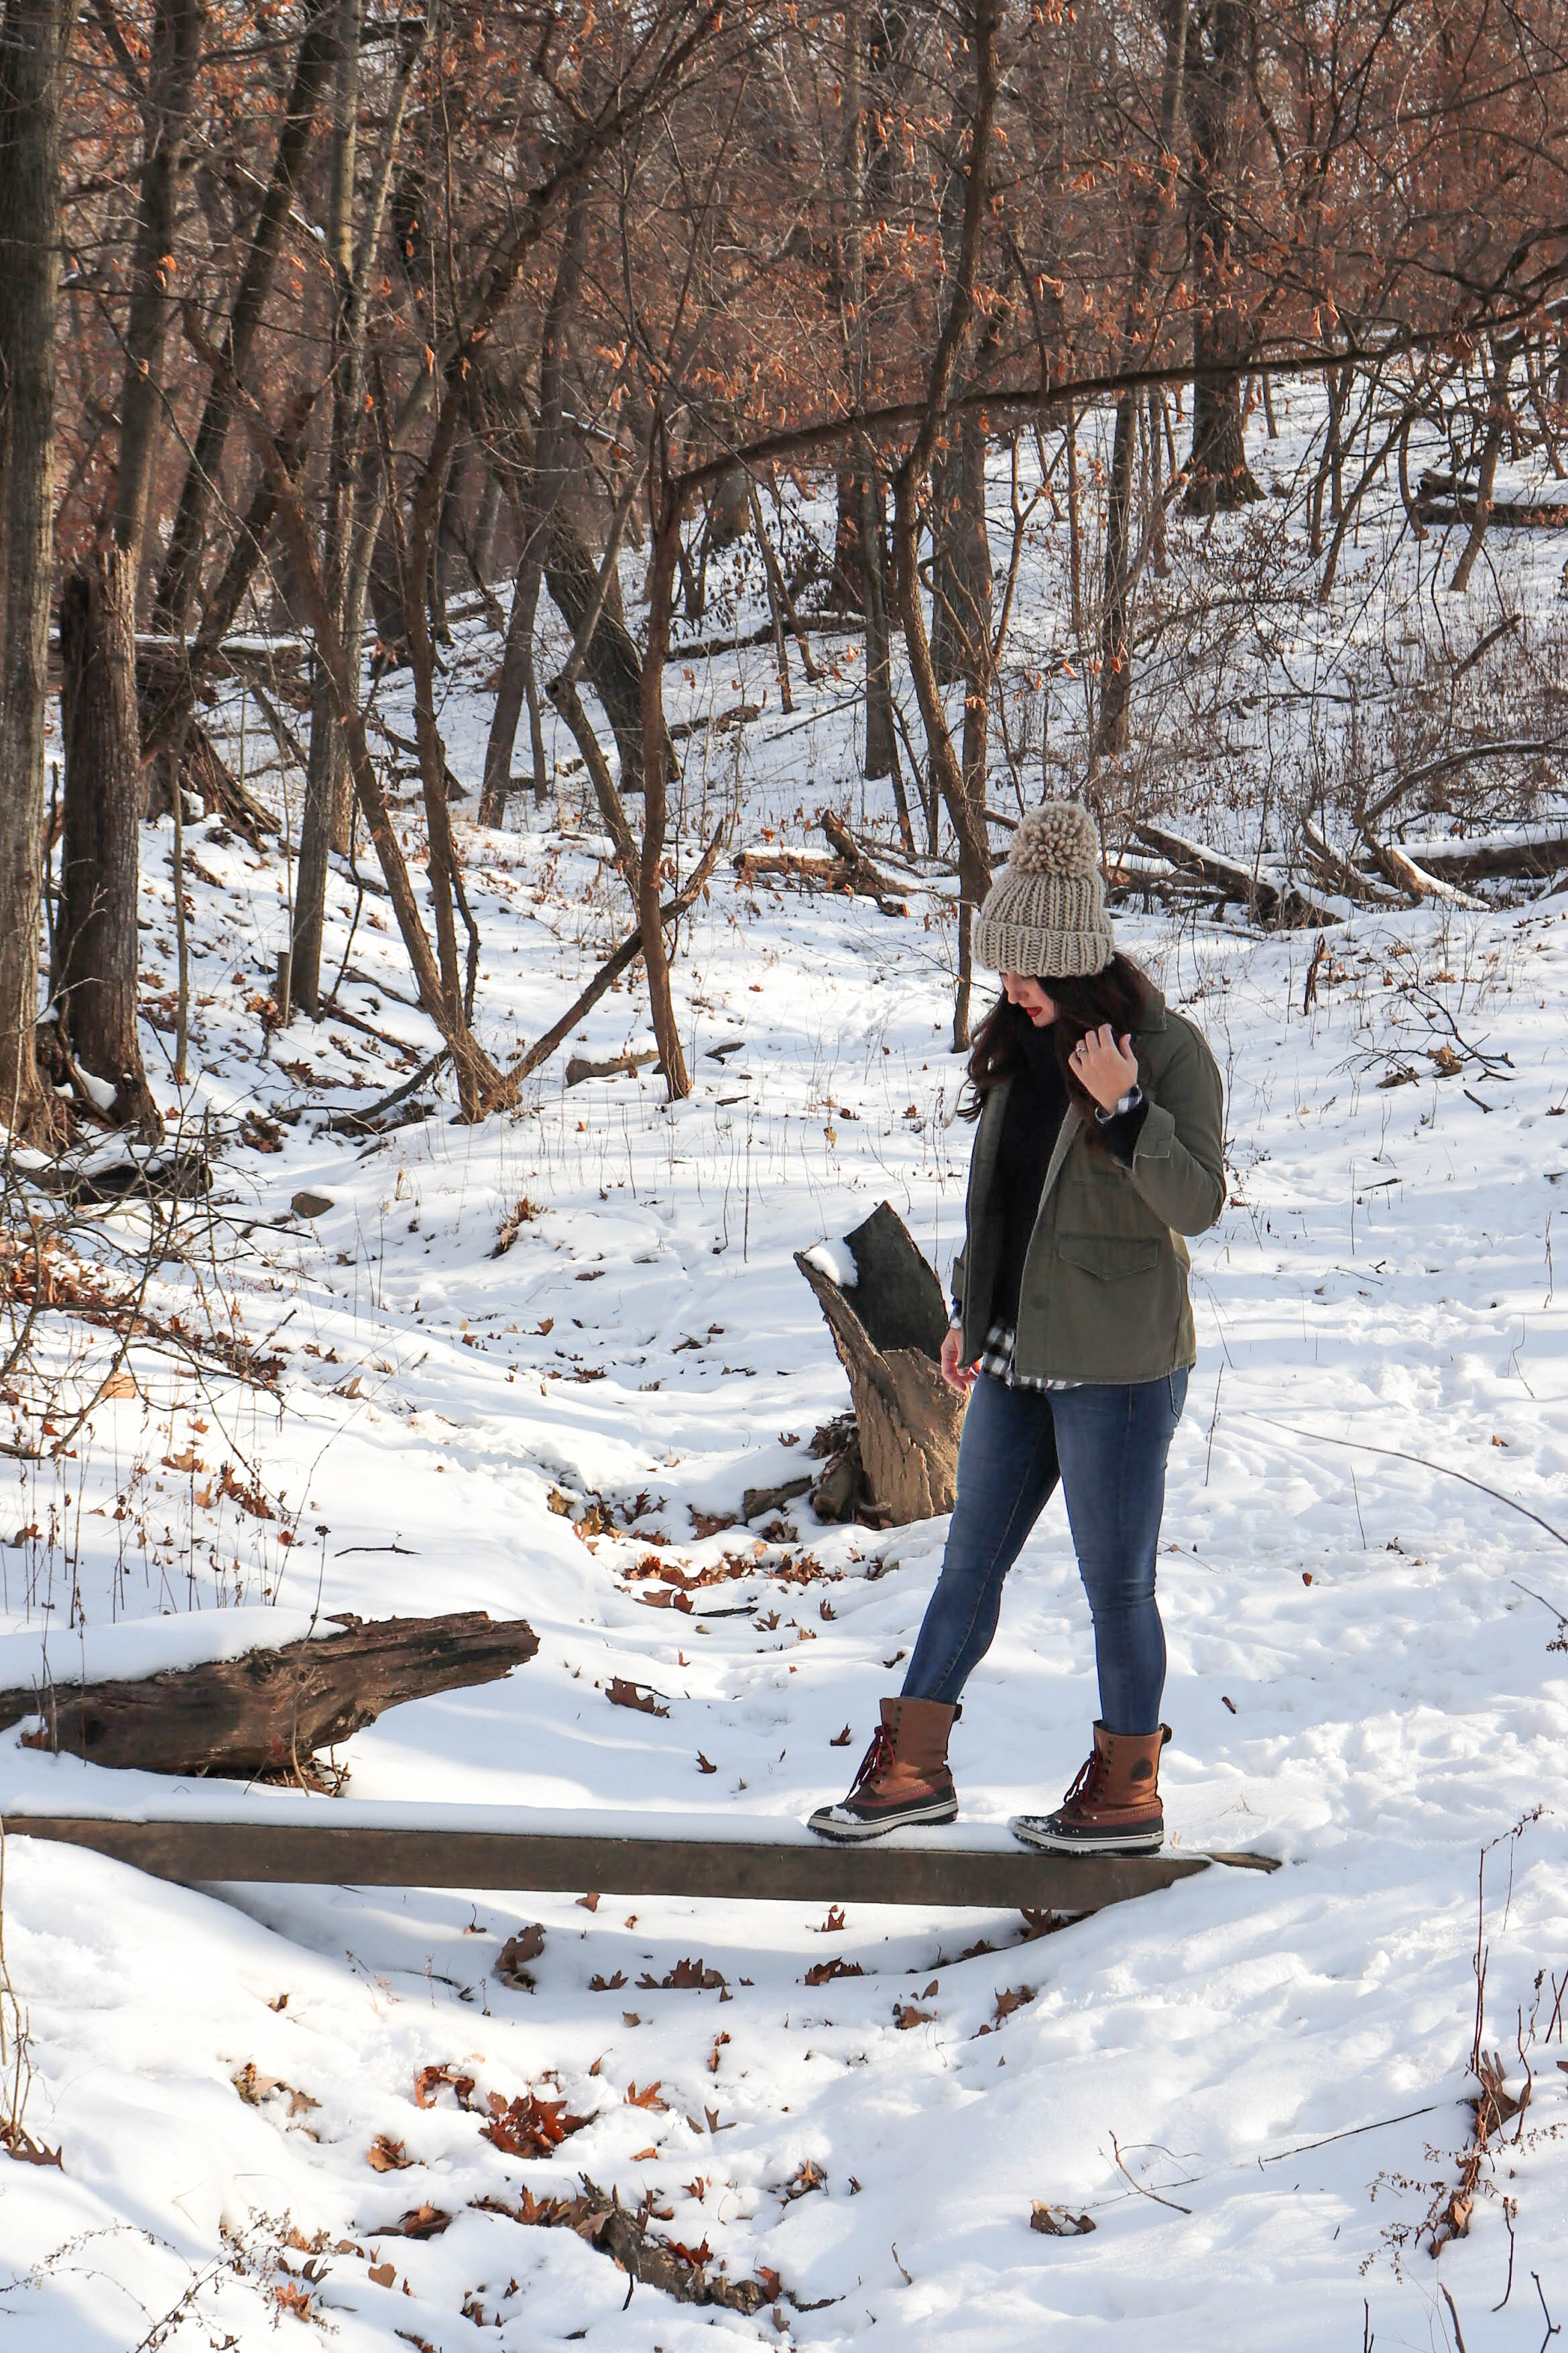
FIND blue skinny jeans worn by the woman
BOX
[903,1369,1187,1737]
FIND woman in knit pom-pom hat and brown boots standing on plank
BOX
[811,800,1225,1854]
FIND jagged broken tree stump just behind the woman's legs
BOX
[794,1202,964,1527]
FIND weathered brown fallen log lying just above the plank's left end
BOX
[0,1609,538,1779]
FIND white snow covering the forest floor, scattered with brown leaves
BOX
[0,395,1568,2353]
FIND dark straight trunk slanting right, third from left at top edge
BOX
[155,0,341,633]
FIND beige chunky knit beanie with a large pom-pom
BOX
[973,800,1117,981]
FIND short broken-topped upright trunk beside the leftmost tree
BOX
[54,544,161,1143]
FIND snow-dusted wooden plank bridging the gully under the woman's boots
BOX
[5,1814,1222,1913]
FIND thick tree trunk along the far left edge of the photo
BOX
[0,0,75,1141]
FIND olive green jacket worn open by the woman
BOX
[952,995,1225,1381]
